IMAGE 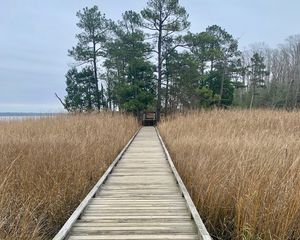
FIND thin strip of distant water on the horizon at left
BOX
[0,112,58,121]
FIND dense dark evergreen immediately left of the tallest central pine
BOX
[105,11,155,115]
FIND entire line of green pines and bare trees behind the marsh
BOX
[60,0,300,118]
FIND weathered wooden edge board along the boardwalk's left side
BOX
[53,128,141,240]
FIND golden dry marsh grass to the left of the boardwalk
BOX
[0,114,138,240]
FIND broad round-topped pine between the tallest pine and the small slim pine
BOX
[184,25,240,106]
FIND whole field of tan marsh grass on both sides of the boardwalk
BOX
[0,110,300,240]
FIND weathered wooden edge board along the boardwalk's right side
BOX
[155,128,212,240]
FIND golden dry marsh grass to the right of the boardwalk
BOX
[159,110,300,240]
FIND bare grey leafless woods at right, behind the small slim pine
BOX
[235,38,300,109]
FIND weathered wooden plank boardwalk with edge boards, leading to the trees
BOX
[54,127,211,240]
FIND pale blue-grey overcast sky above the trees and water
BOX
[0,0,300,112]
